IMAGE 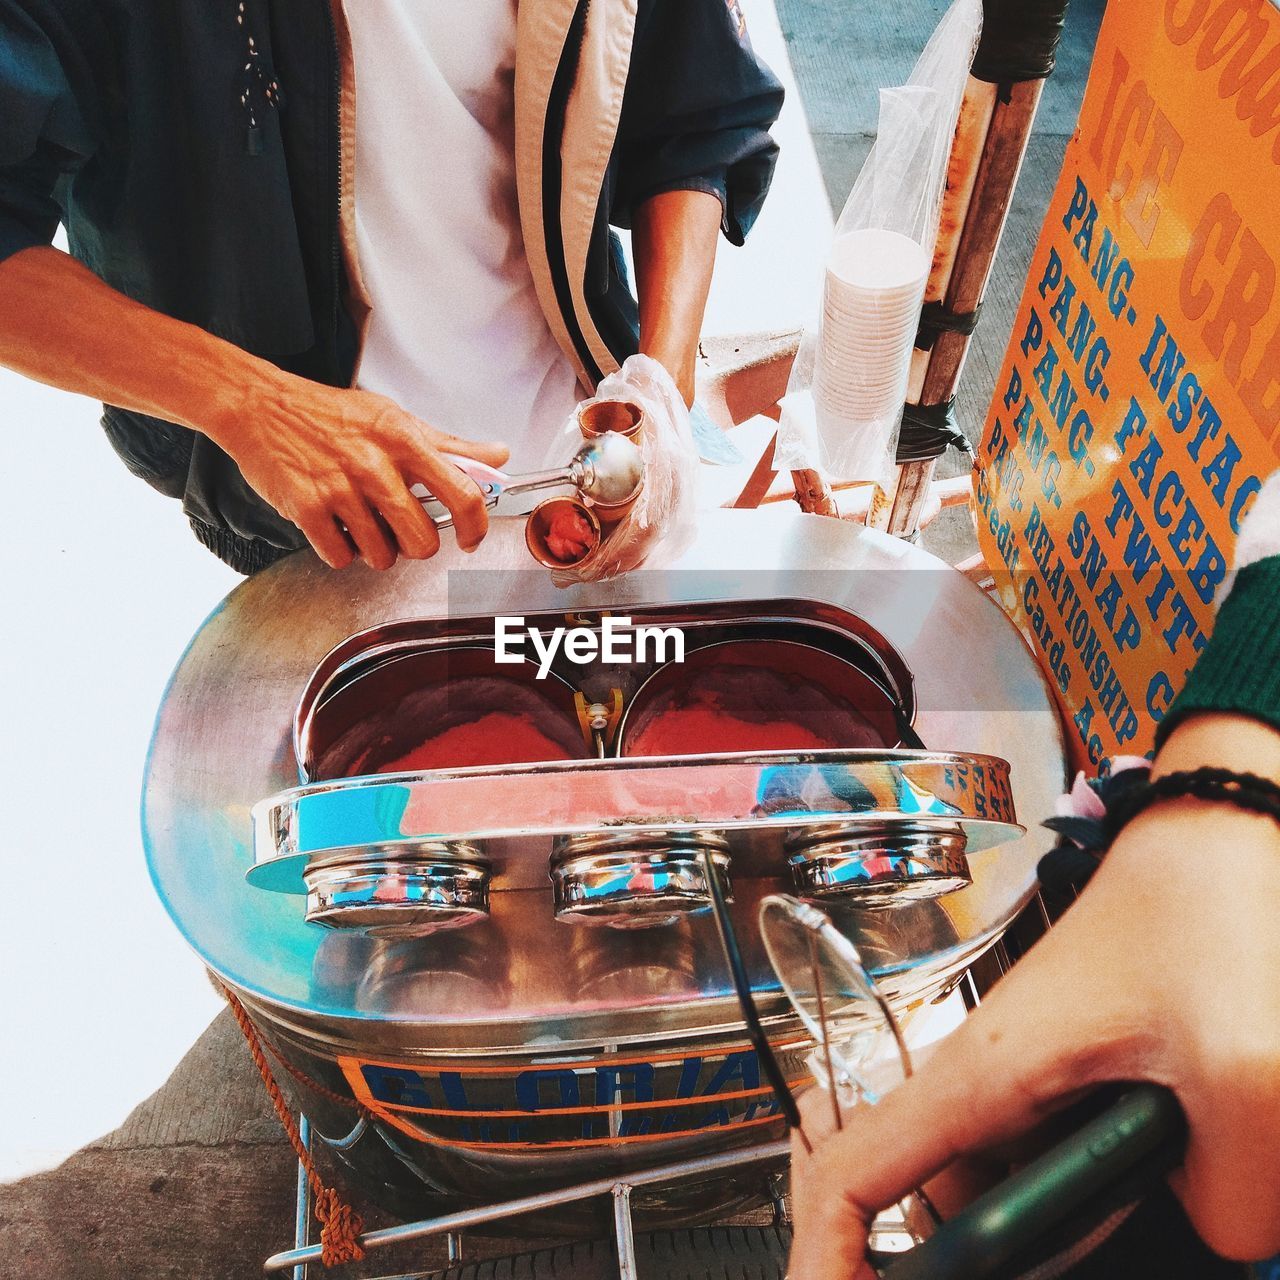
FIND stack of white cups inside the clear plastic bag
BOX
[813,228,929,479]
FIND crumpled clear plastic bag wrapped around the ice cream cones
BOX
[540,356,698,586]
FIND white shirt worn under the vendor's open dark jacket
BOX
[346,0,582,470]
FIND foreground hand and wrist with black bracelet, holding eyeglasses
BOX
[788,716,1280,1280]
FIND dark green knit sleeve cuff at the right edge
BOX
[1156,556,1280,748]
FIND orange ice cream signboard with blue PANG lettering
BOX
[977,0,1280,771]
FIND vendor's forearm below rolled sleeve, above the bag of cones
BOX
[631,191,722,404]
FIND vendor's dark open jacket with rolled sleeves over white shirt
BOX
[0,0,782,572]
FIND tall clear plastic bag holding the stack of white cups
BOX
[774,0,982,481]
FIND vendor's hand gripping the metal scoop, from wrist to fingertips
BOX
[210,375,507,570]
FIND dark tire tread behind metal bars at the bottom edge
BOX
[425,1226,791,1280]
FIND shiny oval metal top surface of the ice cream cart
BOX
[143,507,1064,1052]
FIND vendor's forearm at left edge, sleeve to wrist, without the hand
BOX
[0,247,289,443]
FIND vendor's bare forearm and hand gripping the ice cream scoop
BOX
[0,247,507,568]
